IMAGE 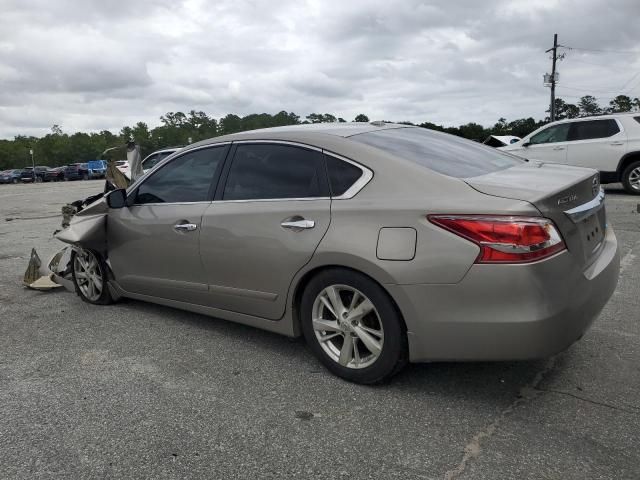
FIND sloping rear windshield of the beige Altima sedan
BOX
[349,127,524,178]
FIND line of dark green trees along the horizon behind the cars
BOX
[0,95,640,170]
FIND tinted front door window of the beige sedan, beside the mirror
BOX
[134,145,227,204]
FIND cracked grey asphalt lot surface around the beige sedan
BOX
[0,181,640,480]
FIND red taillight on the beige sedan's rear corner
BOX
[427,215,566,263]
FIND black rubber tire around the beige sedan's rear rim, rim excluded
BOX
[300,268,408,385]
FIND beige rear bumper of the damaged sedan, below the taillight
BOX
[387,228,620,362]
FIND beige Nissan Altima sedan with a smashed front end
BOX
[58,122,619,383]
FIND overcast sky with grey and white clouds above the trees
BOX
[0,0,640,138]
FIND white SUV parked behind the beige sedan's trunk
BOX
[500,113,640,195]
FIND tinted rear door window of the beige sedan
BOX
[222,144,327,200]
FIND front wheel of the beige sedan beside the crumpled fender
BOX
[71,250,113,305]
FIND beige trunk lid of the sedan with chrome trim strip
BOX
[465,162,606,267]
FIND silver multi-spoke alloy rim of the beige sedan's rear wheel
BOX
[312,285,384,369]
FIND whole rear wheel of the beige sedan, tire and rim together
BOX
[300,268,408,384]
